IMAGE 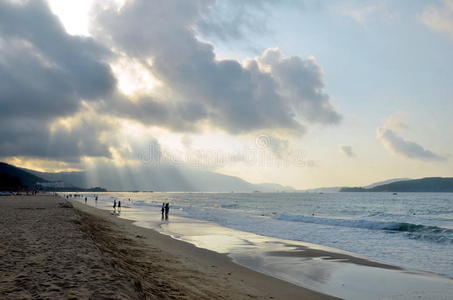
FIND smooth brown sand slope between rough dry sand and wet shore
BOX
[70,200,332,299]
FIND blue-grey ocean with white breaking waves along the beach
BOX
[69,192,453,278]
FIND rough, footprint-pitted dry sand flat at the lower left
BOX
[0,196,140,299]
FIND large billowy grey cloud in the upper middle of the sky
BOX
[92,0,340,133]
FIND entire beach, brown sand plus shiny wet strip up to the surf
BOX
[0,195,453,300]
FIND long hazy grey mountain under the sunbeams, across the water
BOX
[23,165,293,192]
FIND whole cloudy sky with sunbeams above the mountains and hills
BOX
[0,0,453,189]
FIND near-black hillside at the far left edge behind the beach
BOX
[0,162,47,191]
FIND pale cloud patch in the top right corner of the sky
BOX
[420,0,453,38]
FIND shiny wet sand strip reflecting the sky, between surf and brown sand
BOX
[71,199,453,299]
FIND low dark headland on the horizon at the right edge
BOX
[341,177,453,193]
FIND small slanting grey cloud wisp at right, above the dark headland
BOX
[377,127,447,161]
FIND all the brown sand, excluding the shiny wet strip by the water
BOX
[0,196,332,300]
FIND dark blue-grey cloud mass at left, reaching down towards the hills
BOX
[0,0,115,160]
